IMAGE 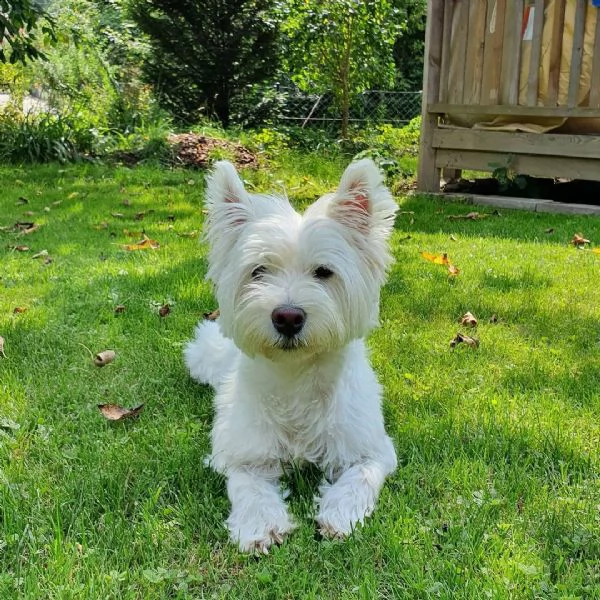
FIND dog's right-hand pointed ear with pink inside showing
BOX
[328,158,398,238]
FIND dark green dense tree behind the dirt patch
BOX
[131,0,279,127]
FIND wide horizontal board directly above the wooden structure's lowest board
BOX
[432,129,600,161]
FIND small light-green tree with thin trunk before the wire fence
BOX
[285,0,403,138]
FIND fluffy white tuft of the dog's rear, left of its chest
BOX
[183,321,239,388]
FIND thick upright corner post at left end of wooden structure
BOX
[417,0,450,192]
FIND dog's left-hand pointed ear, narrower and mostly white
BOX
[205,160,249,228]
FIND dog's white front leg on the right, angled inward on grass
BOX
[316,457,395,538]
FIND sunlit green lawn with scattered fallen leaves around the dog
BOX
[0,158,600,600]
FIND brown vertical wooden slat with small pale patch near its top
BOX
[481,0,506,104]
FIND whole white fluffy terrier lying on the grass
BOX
[185,160,397,552]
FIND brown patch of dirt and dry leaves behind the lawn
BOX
[168,133,258,169]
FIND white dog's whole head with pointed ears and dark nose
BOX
[205,160,397,359]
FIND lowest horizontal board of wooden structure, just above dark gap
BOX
[435,149,600,181]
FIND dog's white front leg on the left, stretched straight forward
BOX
[227,468,294,554]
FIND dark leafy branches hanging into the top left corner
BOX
[0,0,56,64]
